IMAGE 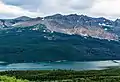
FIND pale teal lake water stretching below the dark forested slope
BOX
[0,60,120,71]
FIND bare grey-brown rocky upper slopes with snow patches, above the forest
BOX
[0,14,120,40]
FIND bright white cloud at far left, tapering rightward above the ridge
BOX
[0,1,40,16]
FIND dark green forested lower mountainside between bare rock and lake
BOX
[0,25,120,63]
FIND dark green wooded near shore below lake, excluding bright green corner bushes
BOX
[0,68,120,82]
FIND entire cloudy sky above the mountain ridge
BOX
[0,0,120,19]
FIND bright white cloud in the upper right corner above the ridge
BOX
[90,0,120,18]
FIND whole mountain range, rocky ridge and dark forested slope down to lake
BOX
[0,14,120,63]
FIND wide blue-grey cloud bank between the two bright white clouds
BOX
[2,0,94,16]
